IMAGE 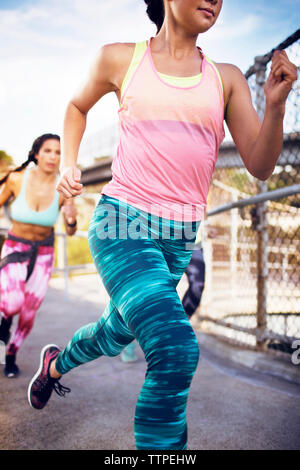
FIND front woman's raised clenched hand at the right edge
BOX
[264,50,298,110]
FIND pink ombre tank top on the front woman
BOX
[101,37,225,221]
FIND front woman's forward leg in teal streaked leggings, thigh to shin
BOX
[87,229,199,450]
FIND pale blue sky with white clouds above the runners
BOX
[0,0,300,164]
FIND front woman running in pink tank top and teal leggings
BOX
[28,0,297,450]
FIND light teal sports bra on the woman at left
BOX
[10,169,59,227]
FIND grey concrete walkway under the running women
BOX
[0,276,300,450]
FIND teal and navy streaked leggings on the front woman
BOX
[56,195,200,450]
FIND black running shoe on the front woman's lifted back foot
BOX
[28,344,71,410]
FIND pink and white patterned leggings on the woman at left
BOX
[0,240,54,354]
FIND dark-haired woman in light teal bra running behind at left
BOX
[0,134,76,377]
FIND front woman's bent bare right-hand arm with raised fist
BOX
[221,51,297,180]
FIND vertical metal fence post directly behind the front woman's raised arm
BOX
[255,56,268,350]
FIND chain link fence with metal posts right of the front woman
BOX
[198,30,300,352]
